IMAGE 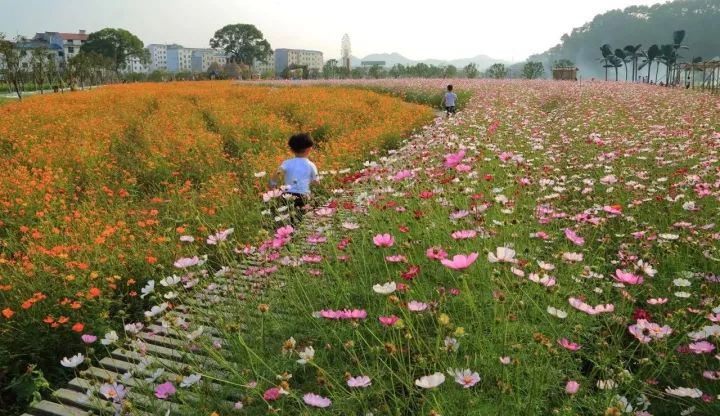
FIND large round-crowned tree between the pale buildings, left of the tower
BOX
[210,23,272,66]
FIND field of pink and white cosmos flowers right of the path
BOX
[117,81,720,416]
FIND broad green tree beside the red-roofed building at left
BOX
[80,28,146,75]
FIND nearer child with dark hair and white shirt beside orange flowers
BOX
[270,133,318,219]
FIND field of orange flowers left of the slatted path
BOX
[0,82,432,413]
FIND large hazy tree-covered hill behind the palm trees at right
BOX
[524,0,720,79]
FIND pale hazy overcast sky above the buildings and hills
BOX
[0,0,664,61]
